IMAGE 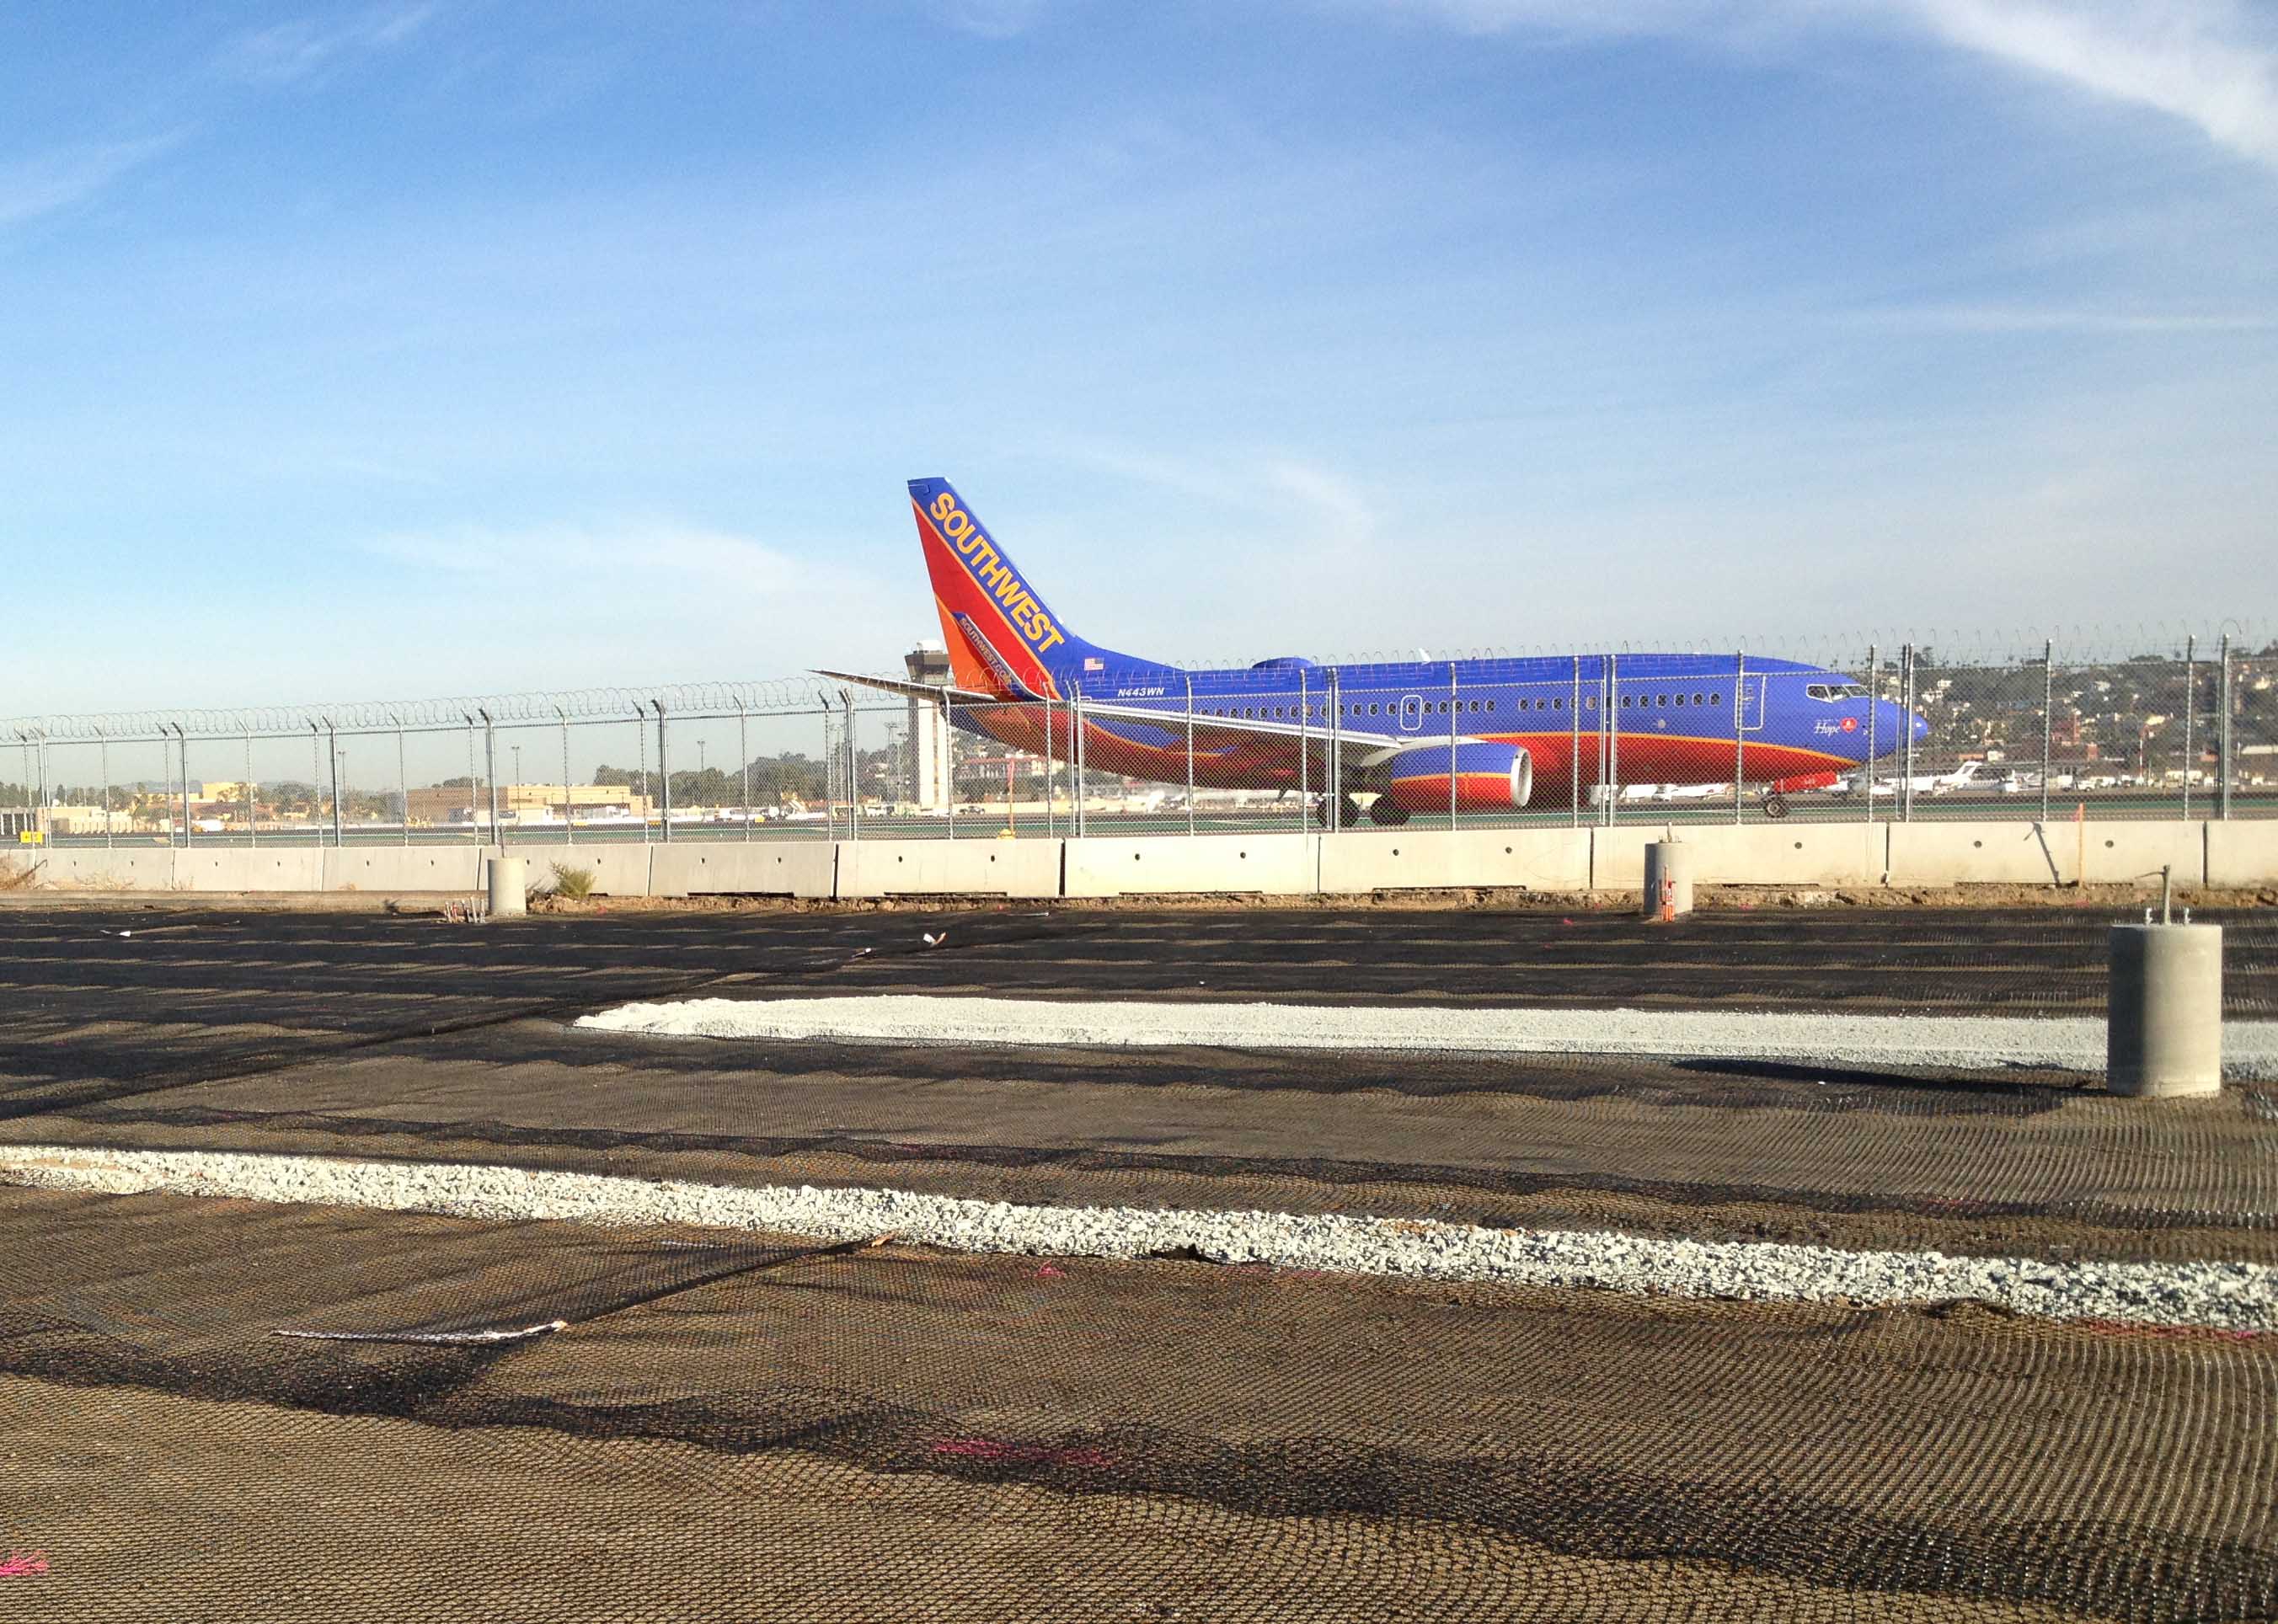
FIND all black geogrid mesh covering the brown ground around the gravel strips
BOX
[0,916,2278,1620]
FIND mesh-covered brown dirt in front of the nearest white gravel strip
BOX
[0,1191,2278,1620]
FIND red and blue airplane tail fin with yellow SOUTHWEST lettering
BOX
[909,478,1155,699]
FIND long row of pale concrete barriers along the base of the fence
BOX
[7,820,2278,897]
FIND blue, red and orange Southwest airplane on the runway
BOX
[822,478,1929,825]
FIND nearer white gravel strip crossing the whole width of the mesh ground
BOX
[0,1146,2278,1330]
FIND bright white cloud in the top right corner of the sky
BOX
[1353,0,2278,166]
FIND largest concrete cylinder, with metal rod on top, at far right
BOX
[2104,925,2223,1100]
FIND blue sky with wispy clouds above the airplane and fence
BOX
[0,0,2278,713]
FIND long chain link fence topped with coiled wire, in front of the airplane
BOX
[0,635,2278,845]
